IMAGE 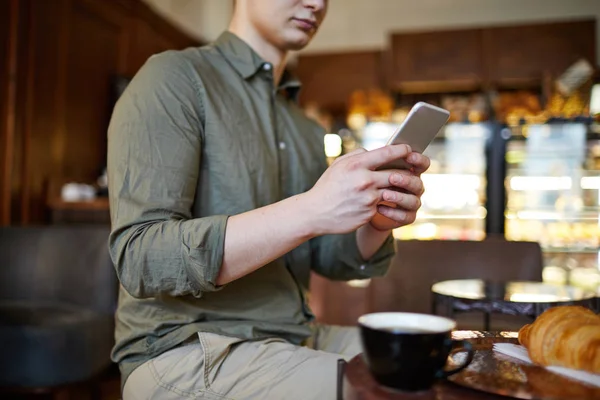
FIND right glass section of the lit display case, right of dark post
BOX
[505,122,600,288]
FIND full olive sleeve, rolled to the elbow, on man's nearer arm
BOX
[108,52,228,298]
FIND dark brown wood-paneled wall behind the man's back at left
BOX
[0,0,200,225]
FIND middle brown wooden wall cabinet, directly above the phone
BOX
[389,29,485,93]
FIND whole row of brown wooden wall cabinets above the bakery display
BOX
[296,19,596,111]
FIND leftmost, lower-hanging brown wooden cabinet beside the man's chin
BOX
[295,51,383,112]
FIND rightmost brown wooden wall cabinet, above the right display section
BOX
[484,20,596,84]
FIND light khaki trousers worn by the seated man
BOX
[123,325,361,400]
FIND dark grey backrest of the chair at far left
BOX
[0,225,118,313]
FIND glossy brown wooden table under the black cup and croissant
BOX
[338,331,600,400]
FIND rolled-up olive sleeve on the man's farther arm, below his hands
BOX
[310,232,395,280]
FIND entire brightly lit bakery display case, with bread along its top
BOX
[356,90,600,288]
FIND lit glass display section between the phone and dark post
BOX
[394,123,492,240]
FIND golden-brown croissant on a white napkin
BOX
[519,306,600,374]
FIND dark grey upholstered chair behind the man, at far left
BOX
[0,225,118,391]
